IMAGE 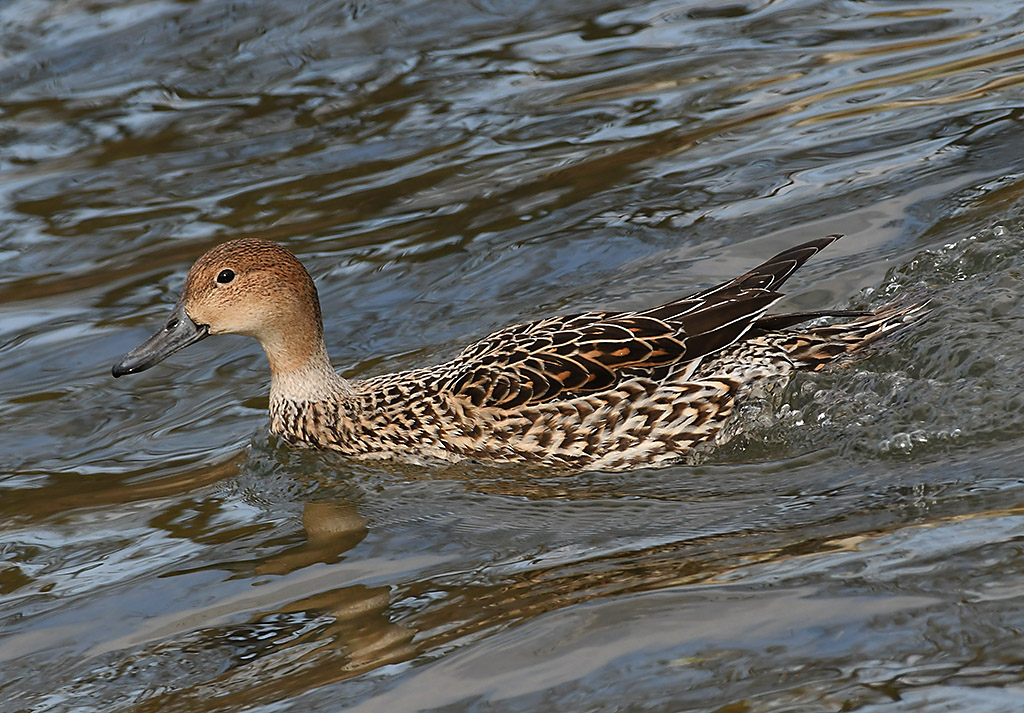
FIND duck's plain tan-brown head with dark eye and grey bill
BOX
[112,238,324,377]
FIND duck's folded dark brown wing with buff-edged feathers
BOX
[441,236,838,409]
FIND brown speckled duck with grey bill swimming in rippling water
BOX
[112,235,927,470]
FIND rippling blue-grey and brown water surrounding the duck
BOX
[0,0,1024,713]
